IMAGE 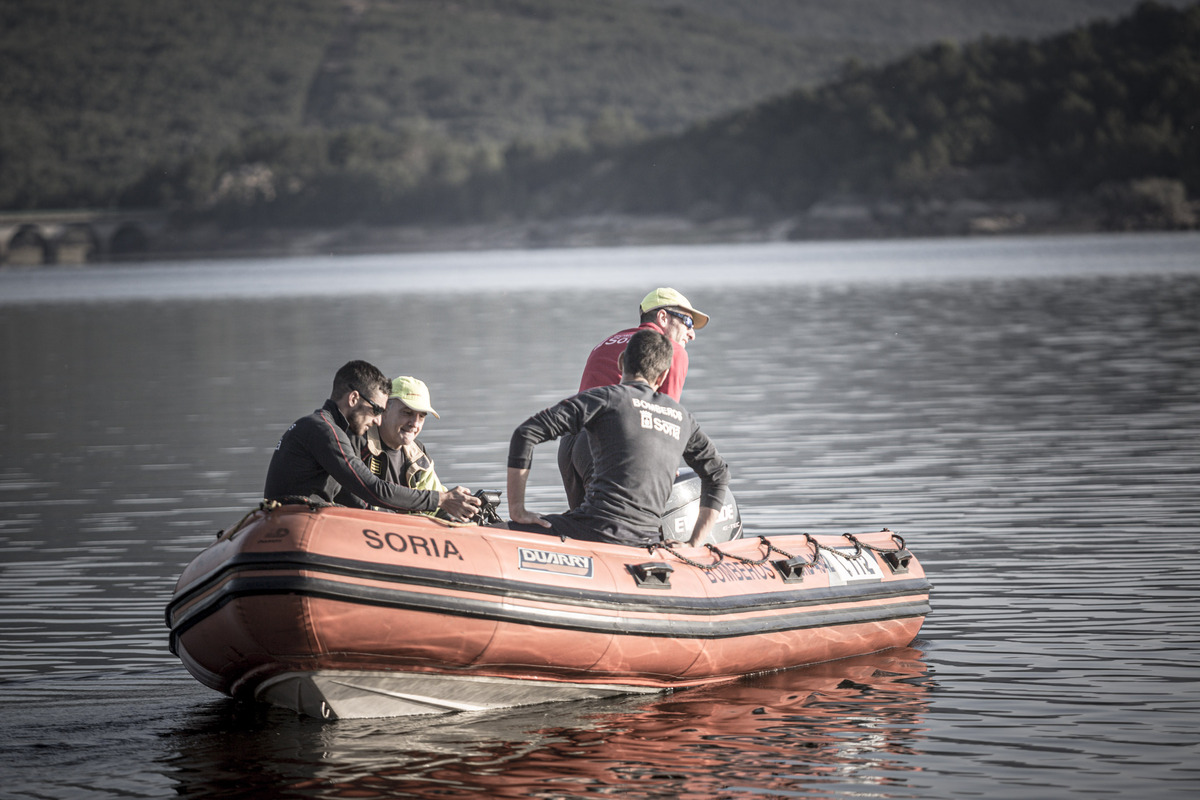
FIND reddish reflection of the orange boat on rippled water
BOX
[157,649,930,798]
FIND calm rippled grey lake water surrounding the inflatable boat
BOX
[0,235,1200,800]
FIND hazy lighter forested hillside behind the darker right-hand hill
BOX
[0,0,1185,224]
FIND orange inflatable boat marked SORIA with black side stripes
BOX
[167,503,930,720]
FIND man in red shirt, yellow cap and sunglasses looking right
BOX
[558,288,708,509]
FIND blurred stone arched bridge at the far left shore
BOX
[0,210,167,265]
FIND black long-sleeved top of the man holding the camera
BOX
[263,399,438,511]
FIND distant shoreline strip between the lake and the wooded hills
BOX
[0,200,1200,269]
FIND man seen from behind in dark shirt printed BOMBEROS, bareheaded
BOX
[508,330,730,546]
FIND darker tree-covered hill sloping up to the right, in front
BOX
[484,2,1200,235]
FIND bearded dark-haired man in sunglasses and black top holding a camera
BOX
[263,361,480,521]
